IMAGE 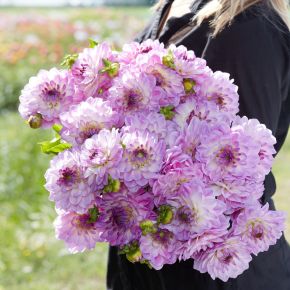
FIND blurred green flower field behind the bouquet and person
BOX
[0,7,290,290]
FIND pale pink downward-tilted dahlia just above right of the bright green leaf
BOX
[60,98,119,145]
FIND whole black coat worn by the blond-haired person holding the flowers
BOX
[107,0,290,290]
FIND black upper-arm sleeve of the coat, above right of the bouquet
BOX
[204,16,290,135]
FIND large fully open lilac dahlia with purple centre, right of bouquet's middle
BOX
[196,126,259,182]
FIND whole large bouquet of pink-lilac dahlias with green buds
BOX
[19,40,285,281]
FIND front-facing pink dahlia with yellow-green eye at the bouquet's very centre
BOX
[119,128,165,191]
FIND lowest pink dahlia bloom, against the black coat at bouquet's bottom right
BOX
[193,237,252,282]
